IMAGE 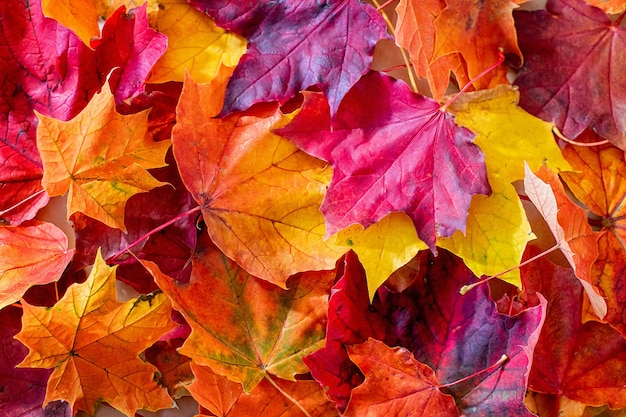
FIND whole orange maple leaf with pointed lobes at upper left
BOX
[37,84,170,232]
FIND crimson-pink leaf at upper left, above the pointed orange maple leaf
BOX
[91,3,167,104]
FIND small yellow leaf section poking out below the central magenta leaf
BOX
[331,213,428,300]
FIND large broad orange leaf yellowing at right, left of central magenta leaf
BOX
[172,74,345,287]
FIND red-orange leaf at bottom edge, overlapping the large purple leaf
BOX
[343,339,459,417]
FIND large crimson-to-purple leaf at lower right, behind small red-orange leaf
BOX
[305,251,545,416]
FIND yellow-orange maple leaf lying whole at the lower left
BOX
[15,252,174,415]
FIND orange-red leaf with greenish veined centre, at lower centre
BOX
[141,236,334,392]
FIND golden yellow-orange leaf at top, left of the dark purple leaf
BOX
[149,0,246,83]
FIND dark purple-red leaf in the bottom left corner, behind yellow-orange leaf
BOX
[0,307,72,417]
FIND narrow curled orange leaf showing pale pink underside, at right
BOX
[524,165,607,319]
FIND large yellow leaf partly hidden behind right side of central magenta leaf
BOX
[437,85,571,285]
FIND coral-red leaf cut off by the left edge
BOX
[0,220,74,310]
